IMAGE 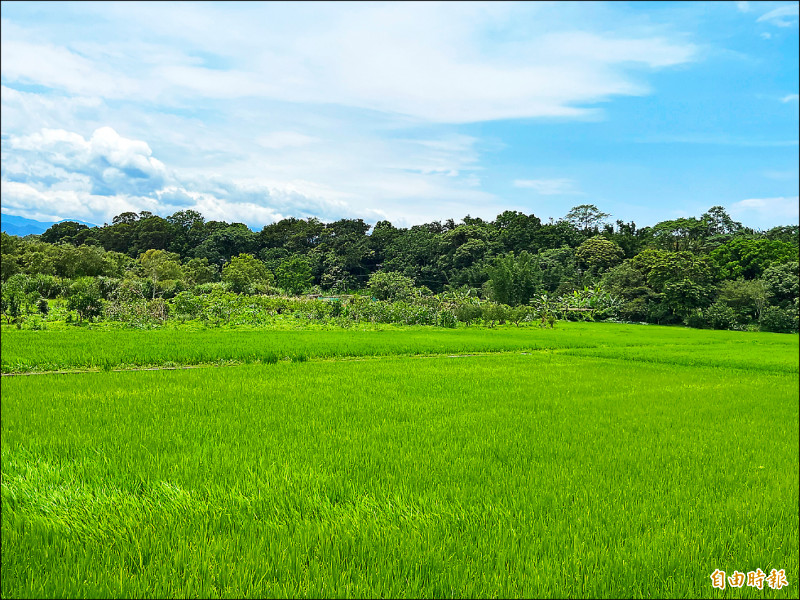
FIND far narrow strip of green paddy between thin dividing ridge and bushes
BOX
[2,322,798,373]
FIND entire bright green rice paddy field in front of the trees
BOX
[2,323,800,598]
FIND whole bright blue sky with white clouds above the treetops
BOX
[0,2,800,229]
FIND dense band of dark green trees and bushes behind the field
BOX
[0,204,798,331]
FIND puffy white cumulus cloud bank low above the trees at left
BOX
[2,127,360,225]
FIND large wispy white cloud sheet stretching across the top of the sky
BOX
[2,3,695,123]
